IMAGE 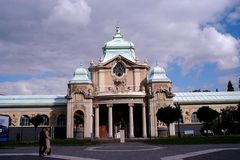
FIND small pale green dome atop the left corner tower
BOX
[69,65,92,84]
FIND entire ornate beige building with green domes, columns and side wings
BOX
[0,26,240,138]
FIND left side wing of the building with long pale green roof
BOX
[0,95,67,139]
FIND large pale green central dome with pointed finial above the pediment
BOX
[101,26,136,63]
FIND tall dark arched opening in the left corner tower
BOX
[73,110,84,139]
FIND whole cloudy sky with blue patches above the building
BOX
[0,0,240,94]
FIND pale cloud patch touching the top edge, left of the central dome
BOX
[45,0,91,27]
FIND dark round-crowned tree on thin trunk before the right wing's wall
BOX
[196,106,219,135]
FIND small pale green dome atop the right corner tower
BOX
[148,65,171,82]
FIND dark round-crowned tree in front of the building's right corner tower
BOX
[156,105,181,137]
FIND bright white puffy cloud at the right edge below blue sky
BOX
[182,26,240,73]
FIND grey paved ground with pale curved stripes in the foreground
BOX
[0,142,240,160]
